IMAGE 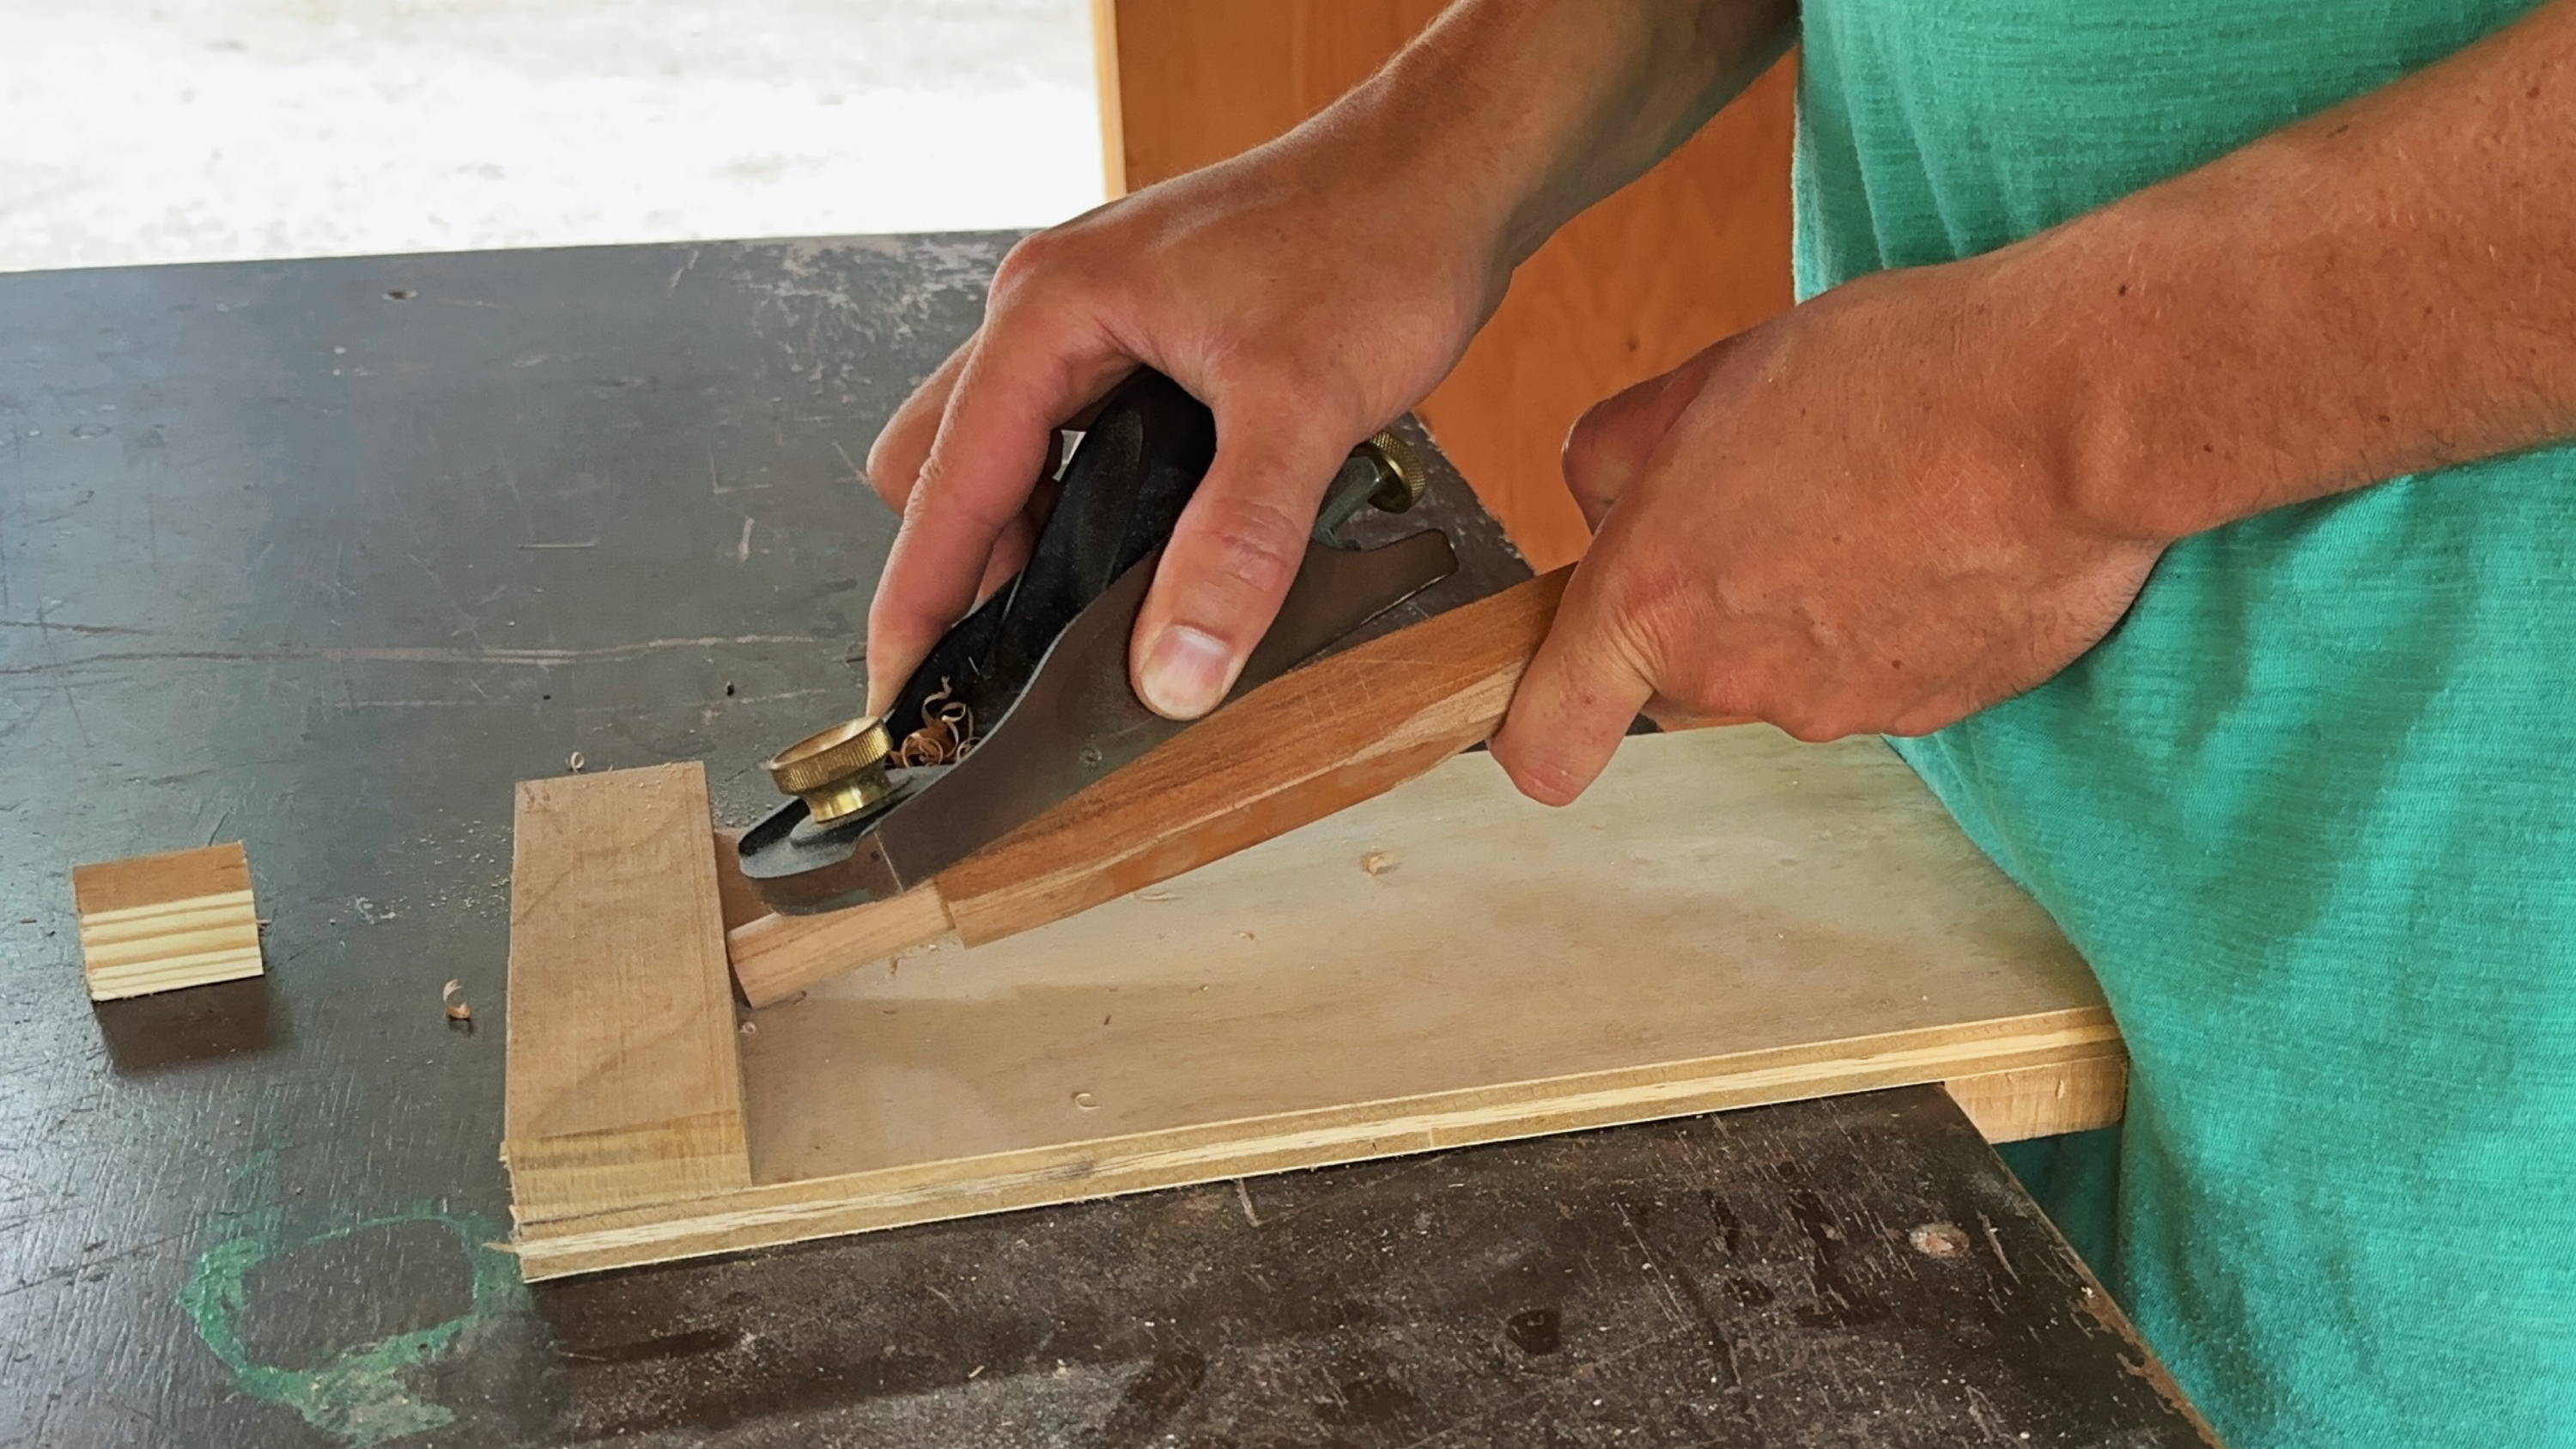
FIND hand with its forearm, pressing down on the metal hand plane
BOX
[868,0,1793,716]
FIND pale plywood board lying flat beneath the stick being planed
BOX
[520,728,2117,1276]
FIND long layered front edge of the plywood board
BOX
[518,1006,2120,1282]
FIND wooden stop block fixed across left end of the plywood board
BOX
[502,764,752,1225]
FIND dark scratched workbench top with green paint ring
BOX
[0,234,2208,1446]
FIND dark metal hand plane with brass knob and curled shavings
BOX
[737,368,1458,916]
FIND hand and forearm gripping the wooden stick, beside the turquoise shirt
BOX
[1494,0,2576,802]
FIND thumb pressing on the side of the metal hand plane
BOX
[1128,407,1355,719]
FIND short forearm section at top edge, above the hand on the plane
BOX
[1283,0,1798,268]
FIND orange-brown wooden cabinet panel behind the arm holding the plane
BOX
[1092,0,1795,569]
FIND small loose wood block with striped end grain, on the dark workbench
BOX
[72,841,263,1001]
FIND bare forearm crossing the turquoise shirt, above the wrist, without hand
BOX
[1968,0,2576,539]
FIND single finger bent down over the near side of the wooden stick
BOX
[1492,559,1654,805]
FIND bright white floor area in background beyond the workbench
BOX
[0,0,1103,271]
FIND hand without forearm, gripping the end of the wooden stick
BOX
[1494,263,2164,805]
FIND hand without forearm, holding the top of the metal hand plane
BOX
[868,126,1510,719]
